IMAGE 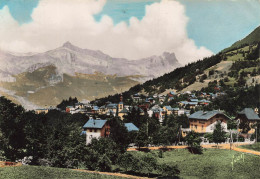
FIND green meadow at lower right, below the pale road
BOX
[129,149,260,179]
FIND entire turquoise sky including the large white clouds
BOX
[0,0,260,64]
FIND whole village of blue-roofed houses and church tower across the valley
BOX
[35,90,260,146]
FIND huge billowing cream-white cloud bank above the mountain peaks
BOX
[0,0,212,64]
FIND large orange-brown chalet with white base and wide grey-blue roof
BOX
[189,110,231,133]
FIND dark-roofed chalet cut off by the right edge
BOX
[235,108,260,134]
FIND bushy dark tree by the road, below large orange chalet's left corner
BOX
[185,131,202,153]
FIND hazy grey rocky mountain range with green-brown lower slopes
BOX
[0,42,181,107]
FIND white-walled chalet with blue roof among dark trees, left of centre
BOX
[83,118,110,144]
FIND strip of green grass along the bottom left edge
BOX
[0,166,121,179]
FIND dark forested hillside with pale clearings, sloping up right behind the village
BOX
[93,27,260,105]
